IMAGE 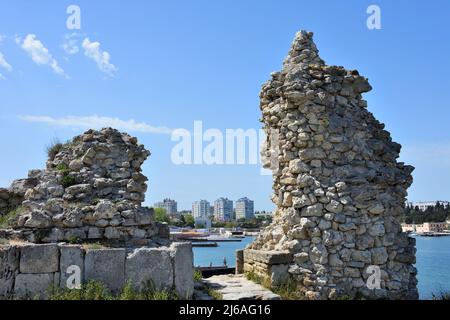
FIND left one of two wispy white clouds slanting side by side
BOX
[16,34,69,78]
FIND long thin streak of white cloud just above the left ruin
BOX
[19,115,173,134]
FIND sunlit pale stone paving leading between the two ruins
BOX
[202,275,281,300]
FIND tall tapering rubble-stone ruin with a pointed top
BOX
[244,31,418,299]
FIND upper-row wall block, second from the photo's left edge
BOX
[20,244,59,273]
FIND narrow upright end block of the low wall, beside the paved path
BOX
[171,242,194,299]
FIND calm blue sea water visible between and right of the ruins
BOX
[194,237,450,299]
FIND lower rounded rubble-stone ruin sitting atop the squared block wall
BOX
[0,128,169,245]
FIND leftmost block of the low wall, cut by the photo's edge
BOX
[0,246,20,300]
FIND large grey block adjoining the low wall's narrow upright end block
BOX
[125,248,174,290]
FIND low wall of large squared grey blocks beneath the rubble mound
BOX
[0,243,194,300]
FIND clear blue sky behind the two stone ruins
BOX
[0,0,450,210]
